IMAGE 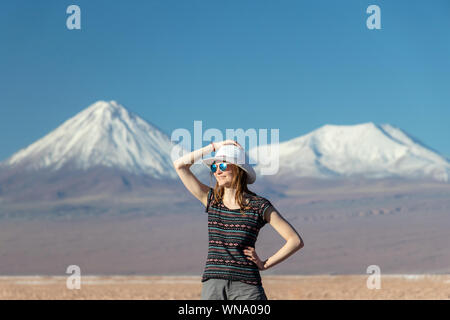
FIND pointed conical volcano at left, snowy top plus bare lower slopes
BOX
[0,101,213,202]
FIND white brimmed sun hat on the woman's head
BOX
[202,144,256,184]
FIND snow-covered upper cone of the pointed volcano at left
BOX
[3,101,181,178]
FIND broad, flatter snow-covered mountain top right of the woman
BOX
[250,122,450,182]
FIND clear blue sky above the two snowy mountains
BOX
[0,0,450,161]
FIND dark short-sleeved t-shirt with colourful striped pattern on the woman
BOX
[202,188,272,285]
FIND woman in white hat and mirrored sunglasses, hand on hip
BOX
[173,140,303,300]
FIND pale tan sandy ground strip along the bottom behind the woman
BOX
[0,275,450,300]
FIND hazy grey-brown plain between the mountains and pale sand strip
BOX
[0,179,450,276]
